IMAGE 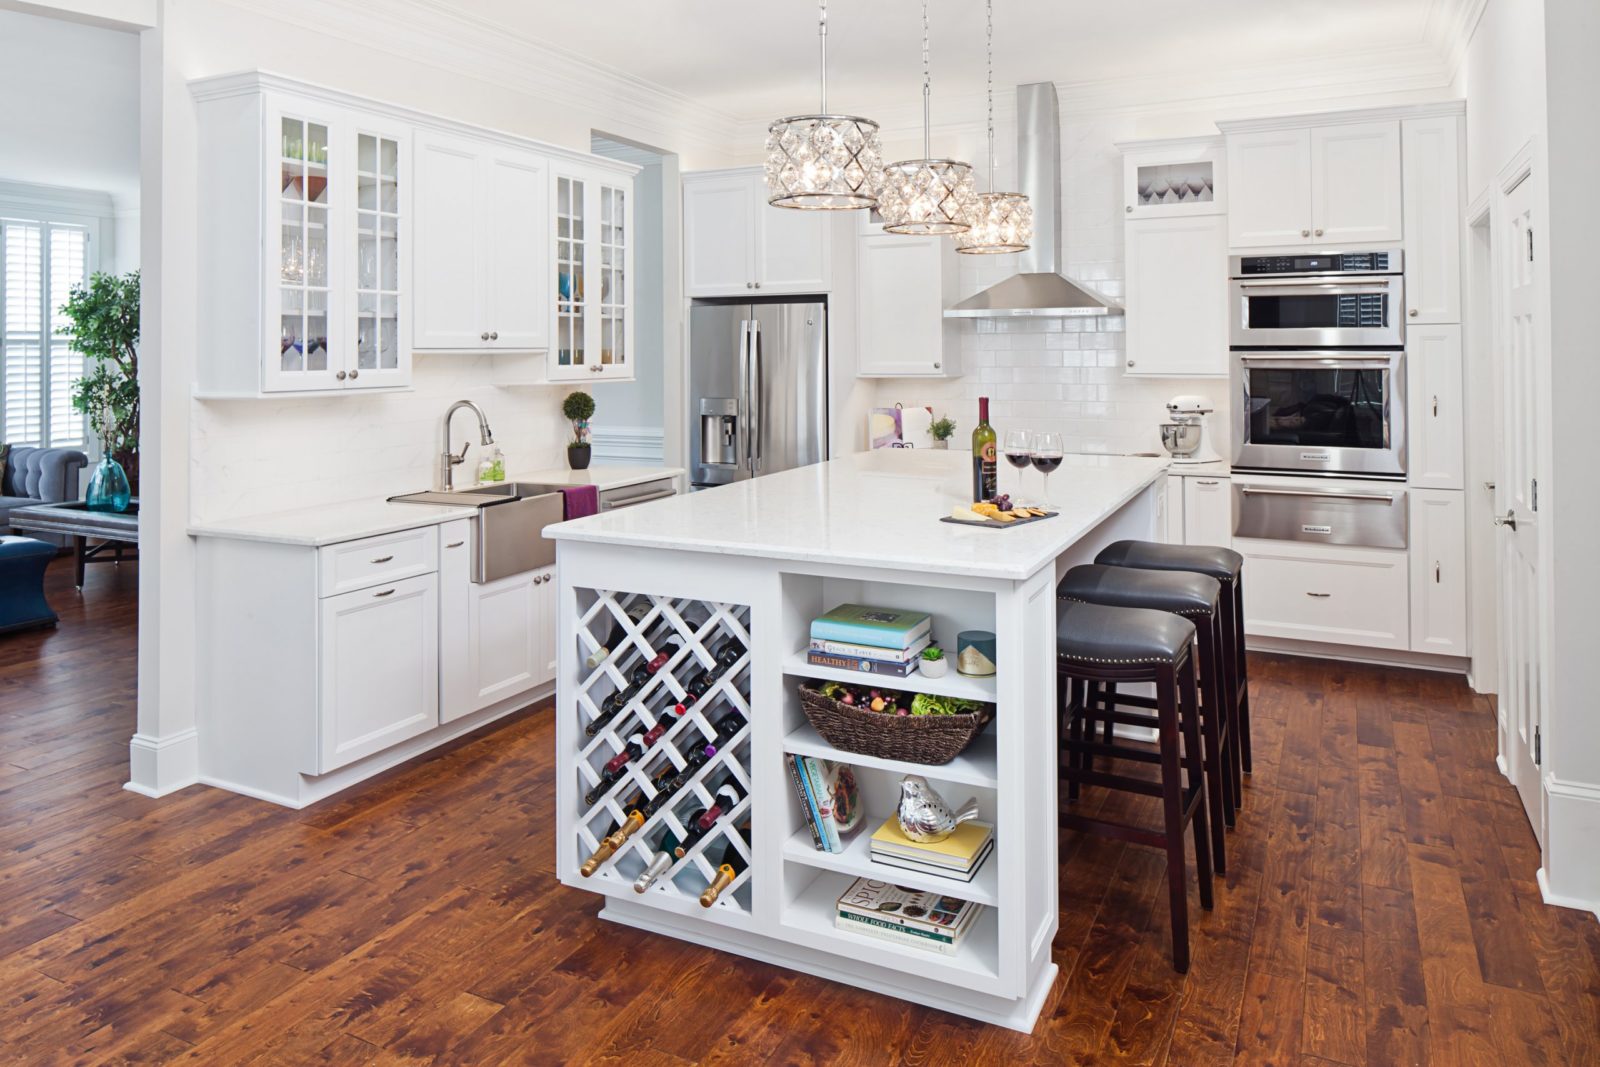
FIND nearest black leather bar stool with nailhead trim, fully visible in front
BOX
[1056,600,1213,974]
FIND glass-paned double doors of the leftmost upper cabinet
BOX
[261,101,411,392]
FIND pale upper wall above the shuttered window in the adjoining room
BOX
[0,11,139,211]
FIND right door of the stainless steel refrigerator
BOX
[747,304,827,477]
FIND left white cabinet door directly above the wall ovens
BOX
[1227,128,1312,248]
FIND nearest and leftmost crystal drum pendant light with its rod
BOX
[766,0,883,211]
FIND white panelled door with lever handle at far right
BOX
[1494,171,1546,846]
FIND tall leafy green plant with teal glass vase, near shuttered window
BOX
[58,270,139,510]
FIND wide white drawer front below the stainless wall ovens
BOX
[1234,539,1411,648]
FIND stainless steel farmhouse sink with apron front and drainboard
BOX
[389,482,563,582]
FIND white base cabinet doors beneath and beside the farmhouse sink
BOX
[438,520,555,723]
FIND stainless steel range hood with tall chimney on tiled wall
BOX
[944,82,1122,318]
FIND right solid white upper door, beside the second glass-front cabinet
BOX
[483,152,550,349]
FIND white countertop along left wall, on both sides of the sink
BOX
[189,467,683,547]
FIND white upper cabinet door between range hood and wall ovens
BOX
[1126,214,1227,378]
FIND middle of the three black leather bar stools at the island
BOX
[1056,563,1238,875]
